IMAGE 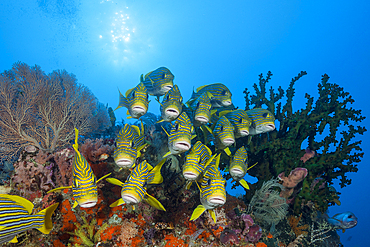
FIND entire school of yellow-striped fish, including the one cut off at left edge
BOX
[0,67,275,243]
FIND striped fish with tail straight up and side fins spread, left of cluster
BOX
[48,128,110,208]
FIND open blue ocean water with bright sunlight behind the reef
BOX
[0,0,370,247]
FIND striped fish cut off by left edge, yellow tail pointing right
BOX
[0,194,59,244]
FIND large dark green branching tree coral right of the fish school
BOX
[238,71,366,213]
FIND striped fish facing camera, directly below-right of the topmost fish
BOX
[159,85,182,122]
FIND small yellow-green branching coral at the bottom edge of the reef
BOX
[68,216,108,247]
